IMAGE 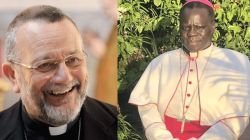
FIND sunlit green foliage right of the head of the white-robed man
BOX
[213,0,250,55]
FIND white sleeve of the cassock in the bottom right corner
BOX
[199,117,249,140]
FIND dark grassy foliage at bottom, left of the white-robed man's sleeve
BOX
[118,114,141,140]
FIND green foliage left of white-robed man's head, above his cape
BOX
[118,0,180,91]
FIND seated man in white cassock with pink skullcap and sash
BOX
[129,0,250,140]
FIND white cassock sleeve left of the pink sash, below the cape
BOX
[138,104,174,140]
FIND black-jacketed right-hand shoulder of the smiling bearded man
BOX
[82,97,118,140]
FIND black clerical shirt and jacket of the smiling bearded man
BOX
[0,97,118,140]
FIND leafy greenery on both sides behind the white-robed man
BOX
[118,0,250,140]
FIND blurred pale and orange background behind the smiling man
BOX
[0,0,117,111]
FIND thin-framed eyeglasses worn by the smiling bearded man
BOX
[8,54,86,73]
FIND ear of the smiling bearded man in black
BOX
[2,63,20,93]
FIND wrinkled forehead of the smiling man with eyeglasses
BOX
[16,21,83,59]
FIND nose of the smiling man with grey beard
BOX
[51,63,73,84]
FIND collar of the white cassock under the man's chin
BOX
[182,44,214,60]
